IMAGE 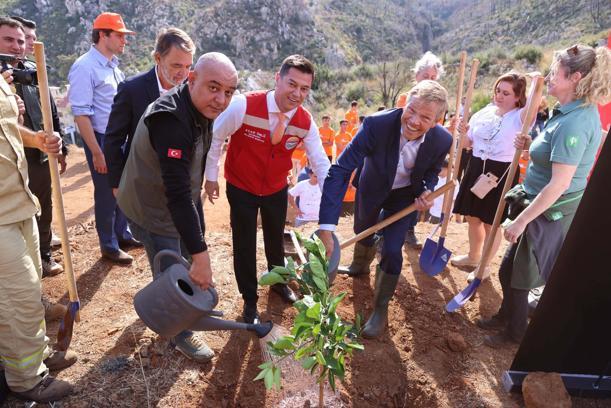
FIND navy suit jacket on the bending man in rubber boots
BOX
[318,109,452,224]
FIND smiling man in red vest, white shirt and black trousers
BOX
[204,55,330,323]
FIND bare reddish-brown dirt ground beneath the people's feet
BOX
[8,148,610,408]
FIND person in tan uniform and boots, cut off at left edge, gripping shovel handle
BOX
[0,71,76,402]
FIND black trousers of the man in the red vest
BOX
[227,183,288,304]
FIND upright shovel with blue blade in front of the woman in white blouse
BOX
[419,51,479,276]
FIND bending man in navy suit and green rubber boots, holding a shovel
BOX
[319,80,452,338]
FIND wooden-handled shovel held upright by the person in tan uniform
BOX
[34,42,80,351]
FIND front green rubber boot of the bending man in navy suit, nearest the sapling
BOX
[361,265,399,339]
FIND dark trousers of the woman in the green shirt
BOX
[498,244,529,341]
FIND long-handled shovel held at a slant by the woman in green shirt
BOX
[446,77,543,312]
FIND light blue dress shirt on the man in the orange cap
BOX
[68,45,125,133]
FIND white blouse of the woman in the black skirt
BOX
[467,103,524,163]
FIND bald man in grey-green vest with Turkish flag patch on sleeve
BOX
[117,52,238,362]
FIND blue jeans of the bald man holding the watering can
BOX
[129,220,193,340]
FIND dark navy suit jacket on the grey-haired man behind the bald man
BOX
[104,67,159,188]
